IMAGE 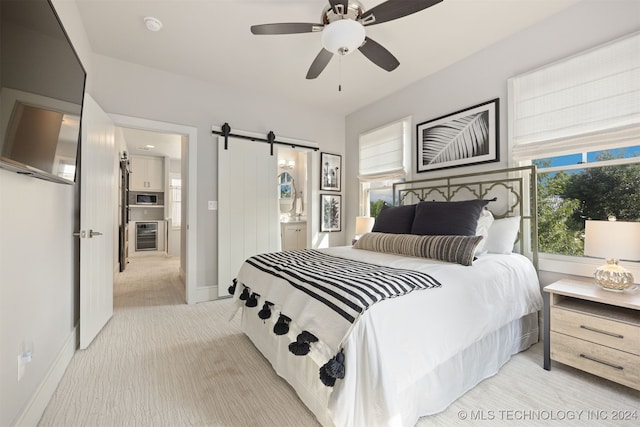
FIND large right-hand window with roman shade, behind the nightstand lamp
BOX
[509,33,640,275]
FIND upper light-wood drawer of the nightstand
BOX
[551,307,640,355]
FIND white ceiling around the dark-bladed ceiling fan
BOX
[76,0,580,114]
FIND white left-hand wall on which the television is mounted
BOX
[0,0,92,426]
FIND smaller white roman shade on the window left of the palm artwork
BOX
[358,120,408,182]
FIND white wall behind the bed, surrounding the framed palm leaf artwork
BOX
[345,0,640,247]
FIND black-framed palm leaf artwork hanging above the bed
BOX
[416,98,500,173]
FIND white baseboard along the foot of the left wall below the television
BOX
[15,326,78,427]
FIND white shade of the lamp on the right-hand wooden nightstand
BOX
[584,220,640,261]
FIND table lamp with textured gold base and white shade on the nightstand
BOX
[584,217,640,292]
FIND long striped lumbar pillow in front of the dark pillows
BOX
[354,233,482,265]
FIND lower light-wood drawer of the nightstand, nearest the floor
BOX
[551,332,640,390]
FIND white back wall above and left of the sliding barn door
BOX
[93,55,345,294]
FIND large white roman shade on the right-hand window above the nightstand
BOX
[509,32,640,160]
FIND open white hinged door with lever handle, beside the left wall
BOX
[79,94,118,349]
